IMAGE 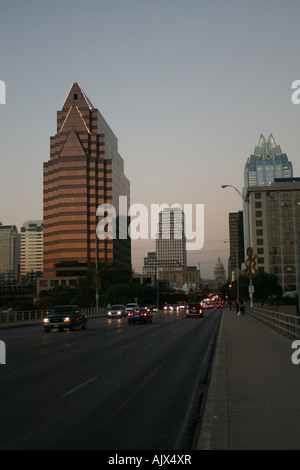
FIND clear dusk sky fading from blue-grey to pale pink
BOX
[0,0,300,278]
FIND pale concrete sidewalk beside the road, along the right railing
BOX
[197,309,300,450]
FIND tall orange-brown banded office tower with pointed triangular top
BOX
[43,83,131,277]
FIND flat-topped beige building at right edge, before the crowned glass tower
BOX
[246,178,300,292]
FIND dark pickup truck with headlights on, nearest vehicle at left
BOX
[44,305,87,333]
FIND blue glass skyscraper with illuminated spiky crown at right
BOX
[243,134,293,252]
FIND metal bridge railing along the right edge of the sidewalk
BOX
[245,306,300,339]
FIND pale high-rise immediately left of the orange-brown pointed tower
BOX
[21,220,43,280]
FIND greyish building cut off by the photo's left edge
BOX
[0,223,20,282]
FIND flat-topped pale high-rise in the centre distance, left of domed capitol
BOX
[156,208,187,278]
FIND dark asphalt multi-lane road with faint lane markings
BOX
[0,310,221,450]
